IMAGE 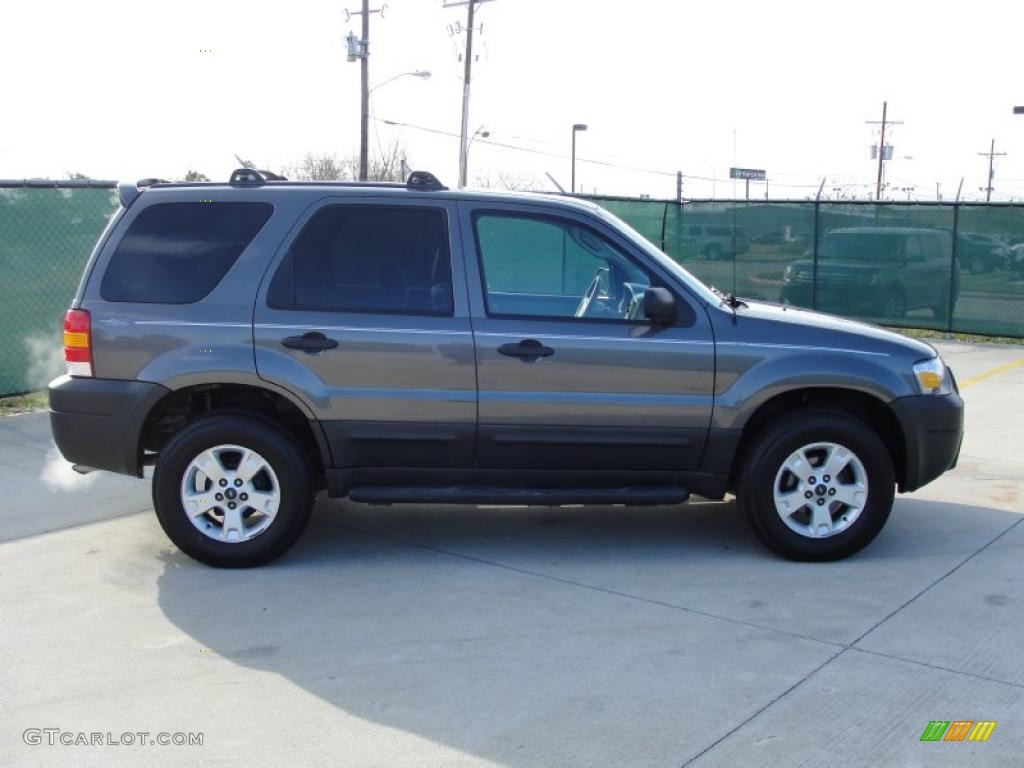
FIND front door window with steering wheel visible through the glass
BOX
[473,212,651,321]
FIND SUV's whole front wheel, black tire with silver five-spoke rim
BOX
[737,410,895,561]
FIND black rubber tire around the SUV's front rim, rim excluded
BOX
[736,409,895,562]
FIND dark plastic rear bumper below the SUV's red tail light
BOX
[49,376,170,477]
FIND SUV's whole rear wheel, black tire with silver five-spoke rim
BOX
[153,414,313,567]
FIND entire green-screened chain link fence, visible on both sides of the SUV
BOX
[0,181,1024,394]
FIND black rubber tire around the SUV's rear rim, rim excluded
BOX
[153,414,313,568]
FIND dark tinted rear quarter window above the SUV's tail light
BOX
[99,203,273,304]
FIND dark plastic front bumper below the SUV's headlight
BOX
[889,391,964,494]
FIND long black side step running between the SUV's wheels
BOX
[348,485,690,507]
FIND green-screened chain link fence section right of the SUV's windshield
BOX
[590,197,1024,337]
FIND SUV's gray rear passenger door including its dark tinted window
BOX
[253,195,476,468]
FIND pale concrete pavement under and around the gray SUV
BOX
[0,344,1024,766]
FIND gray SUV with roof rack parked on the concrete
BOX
[50,170,963,566]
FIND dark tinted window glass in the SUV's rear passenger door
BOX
[267,206,454,315]
